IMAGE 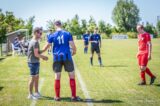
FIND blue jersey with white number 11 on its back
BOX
[48,30,73,61]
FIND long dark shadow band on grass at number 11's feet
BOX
[40,96,123,103]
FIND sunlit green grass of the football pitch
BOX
[0,39,160,106]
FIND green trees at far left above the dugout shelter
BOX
[0,9,35,43]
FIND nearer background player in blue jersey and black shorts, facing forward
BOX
[90,28,102,66]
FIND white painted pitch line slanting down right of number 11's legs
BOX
[74,62,93,106]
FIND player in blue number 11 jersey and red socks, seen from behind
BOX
[43,21,81,101]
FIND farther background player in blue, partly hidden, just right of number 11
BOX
[83,31,90,53]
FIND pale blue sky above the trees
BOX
[0,0,160,29]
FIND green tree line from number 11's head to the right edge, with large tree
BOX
[47,0,160,38]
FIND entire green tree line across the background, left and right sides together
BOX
[0,0,160,43]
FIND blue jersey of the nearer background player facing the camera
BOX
[90,34,101,46]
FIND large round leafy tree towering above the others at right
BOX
[112,0,140,31]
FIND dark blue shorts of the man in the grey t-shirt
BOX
[28,63,40,76]
